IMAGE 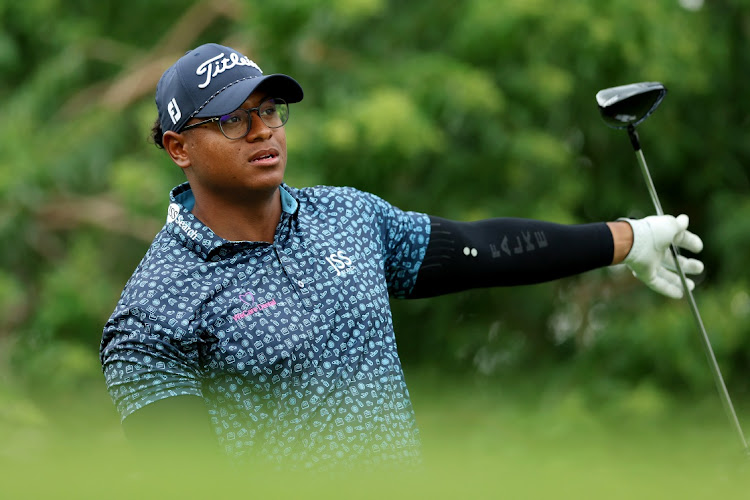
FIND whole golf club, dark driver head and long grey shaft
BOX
[596,82,750,455]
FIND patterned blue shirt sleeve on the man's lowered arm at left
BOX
[99,306,203,419]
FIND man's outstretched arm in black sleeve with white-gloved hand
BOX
[408,215,703,298]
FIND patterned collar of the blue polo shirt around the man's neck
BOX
[165,182,299,260]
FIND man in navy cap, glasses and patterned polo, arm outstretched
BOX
[101,44,703,467]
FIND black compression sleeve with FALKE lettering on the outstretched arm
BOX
[409,216,614,298]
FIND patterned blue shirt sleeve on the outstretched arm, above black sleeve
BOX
[360,195,430,298]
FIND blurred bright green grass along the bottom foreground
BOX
[0,374,750,499]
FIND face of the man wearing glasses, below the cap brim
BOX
[179,92,287,201]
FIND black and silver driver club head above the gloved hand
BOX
[596,82,667,129]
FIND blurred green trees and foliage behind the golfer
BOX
[0,0,750,446]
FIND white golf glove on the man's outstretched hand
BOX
[620,214,703,299]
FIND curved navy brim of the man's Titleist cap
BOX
[193,74,304,118]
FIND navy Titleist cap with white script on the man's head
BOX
[156,43,303,132]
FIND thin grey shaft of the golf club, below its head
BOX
[635,147,750,455]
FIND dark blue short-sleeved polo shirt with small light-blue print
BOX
[100,183,430,467]
